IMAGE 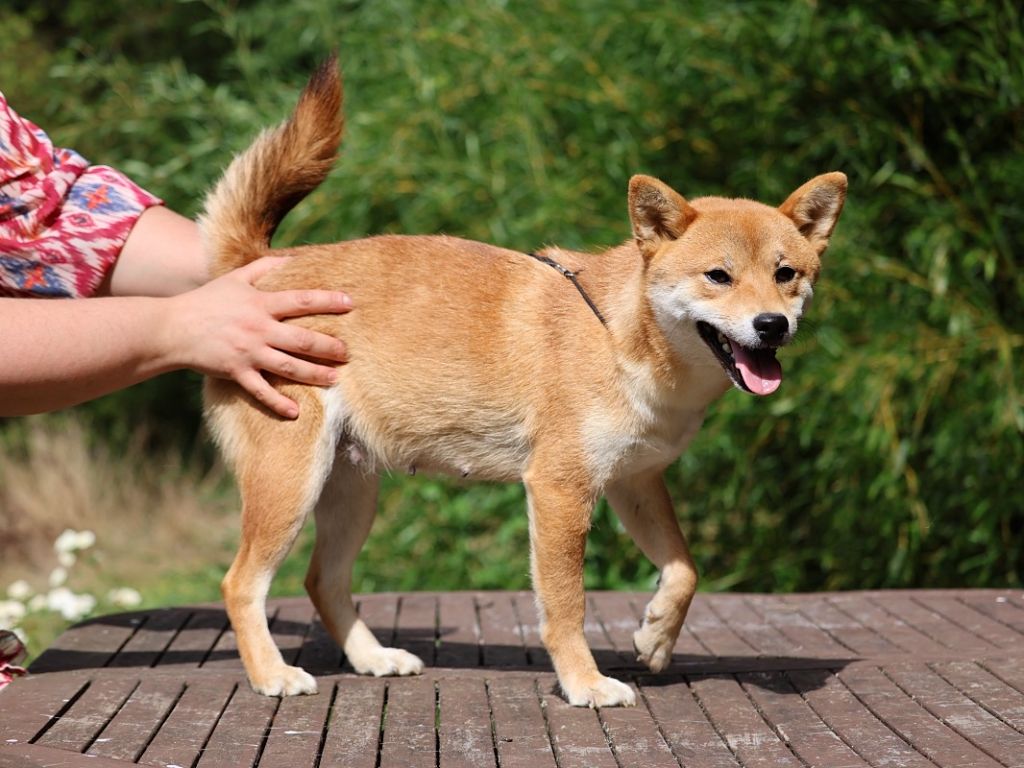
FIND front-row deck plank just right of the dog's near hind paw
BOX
[319,678,386,768]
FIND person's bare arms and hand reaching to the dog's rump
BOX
[0,208,350,418]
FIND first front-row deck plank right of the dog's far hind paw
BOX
[437,677,495,768]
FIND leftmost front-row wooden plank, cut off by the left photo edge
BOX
[0,673,89,745]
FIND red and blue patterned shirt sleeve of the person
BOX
[0,88,163,298]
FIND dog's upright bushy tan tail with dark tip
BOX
[199,56,344,278]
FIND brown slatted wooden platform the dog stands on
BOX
[0,590,1024,768]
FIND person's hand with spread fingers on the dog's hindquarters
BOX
[160,256,352,419]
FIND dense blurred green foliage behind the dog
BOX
[0,0,1024,590]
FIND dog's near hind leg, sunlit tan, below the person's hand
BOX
[221,409,329,696]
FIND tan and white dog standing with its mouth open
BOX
[203,59,846,707]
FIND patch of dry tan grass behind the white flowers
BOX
[0,417,237,651]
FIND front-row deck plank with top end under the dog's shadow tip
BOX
[786,670,935,768]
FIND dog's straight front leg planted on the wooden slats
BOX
[524,472,636,707]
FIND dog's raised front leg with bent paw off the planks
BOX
[605,472,697,672]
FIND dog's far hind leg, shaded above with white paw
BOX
[306,456,423,677]
